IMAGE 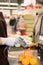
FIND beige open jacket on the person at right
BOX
[33,13,43,42]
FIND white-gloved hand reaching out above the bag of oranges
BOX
[15,35,31,47]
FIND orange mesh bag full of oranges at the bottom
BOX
[18,48,38,65]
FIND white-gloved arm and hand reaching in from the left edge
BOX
[0,35,30,46]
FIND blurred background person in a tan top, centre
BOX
[17,15,27,36]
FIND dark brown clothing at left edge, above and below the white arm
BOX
[0,12,9,65]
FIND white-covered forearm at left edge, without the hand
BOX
[0,38,15,46]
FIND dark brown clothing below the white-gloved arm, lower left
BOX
[0,45,9,65]
